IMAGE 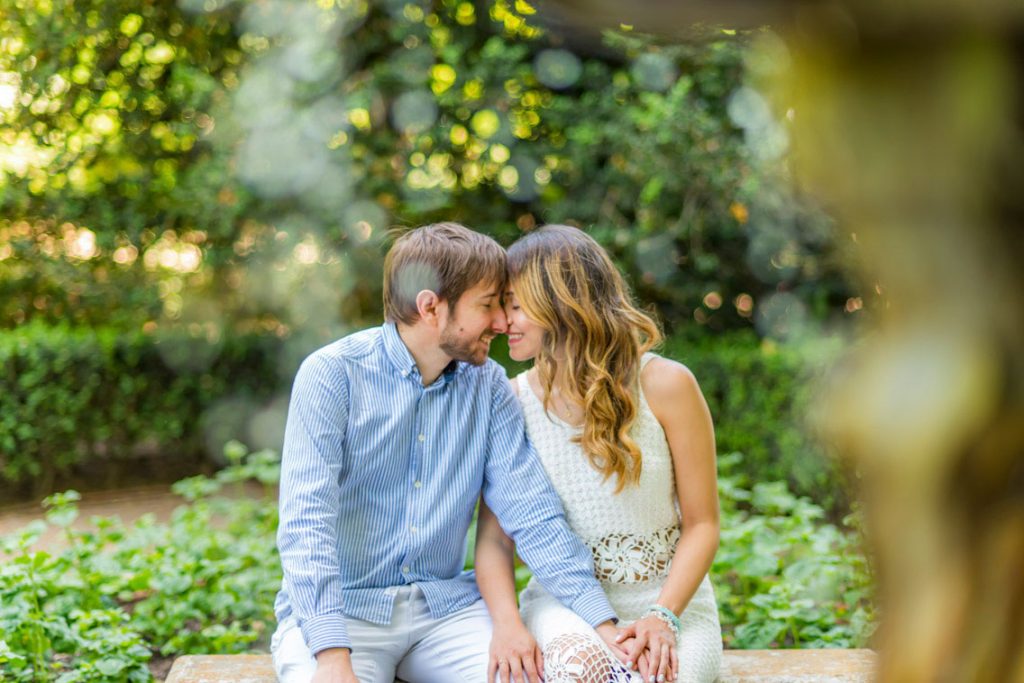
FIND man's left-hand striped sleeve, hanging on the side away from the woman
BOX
[278,352,351,655]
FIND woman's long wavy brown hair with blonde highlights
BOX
[508,225,662,494]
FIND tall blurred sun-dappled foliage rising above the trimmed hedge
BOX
[0,0,847,330]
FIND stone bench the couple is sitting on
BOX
[167,649,876,683]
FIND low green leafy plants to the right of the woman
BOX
[712,454,874,649]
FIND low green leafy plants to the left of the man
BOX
[0,444,281,683]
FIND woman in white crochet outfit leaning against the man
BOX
[476,225,722,683]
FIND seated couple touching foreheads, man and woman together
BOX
[271,223,722,683]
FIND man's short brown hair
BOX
[384,223,505,325]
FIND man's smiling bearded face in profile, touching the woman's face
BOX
[440,283,507,366]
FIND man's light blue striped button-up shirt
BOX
[274,324,614,653]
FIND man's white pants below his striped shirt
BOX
[270,585,492,683]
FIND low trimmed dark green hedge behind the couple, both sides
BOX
[0,324,848,517]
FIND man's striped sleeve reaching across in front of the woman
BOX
[483,373,615,626]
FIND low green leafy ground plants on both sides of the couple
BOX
[0,442,874,681]
